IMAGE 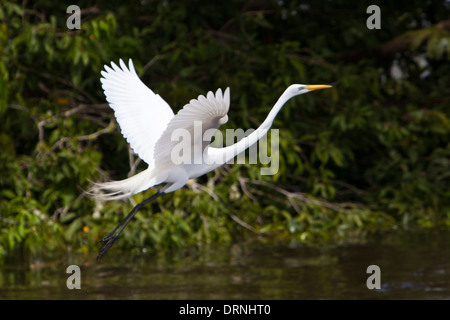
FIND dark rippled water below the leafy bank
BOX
[0,231,450,299]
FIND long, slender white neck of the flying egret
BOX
[210,90,294,164]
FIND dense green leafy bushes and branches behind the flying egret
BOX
[0,0,450,256]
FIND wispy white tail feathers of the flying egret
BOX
[88,169,155,200]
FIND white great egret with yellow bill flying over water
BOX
[94,59,331,260]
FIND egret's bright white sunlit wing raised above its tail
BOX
[100,59,174,165]
